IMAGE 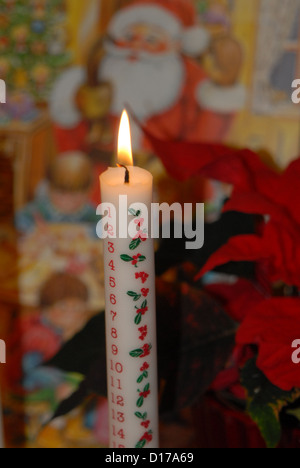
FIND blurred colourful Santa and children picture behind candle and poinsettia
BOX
[0,0,300,448]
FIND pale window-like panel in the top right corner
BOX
[253,0,300,118]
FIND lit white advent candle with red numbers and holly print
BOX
[99,112,159,448]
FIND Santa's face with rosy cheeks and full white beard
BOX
[99,23,185,121]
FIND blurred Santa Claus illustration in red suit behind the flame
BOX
[51,0,245,151]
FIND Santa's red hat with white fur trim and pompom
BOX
[108,0,209,56]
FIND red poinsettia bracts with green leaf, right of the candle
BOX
[144,126,300,447]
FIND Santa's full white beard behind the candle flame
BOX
[99,44,185,121]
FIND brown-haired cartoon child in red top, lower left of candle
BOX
[8,273,89,392]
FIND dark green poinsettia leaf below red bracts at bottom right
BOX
[241,359,300,448]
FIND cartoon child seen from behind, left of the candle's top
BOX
[16,152,97,232]
